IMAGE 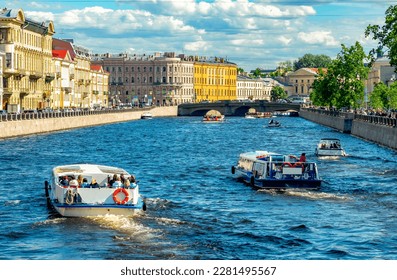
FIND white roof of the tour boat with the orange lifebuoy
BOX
[53,163,130,176]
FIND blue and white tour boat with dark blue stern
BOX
[232,151,322,189]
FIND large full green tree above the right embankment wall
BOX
[310,42,369,109]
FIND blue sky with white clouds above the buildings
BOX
[0,0,397,72]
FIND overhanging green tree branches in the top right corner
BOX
[365,5,397,66]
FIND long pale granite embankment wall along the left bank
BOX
[0,106,178,139]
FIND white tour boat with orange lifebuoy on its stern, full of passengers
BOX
[45,164,146,217]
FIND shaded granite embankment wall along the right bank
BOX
[299,108,397,150]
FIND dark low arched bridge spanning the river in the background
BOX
[178,100,300,116]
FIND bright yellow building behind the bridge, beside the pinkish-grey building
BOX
[194,58,237,102]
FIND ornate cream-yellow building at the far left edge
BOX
[0,8,55,111]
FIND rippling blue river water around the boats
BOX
[0,117,397,260]
